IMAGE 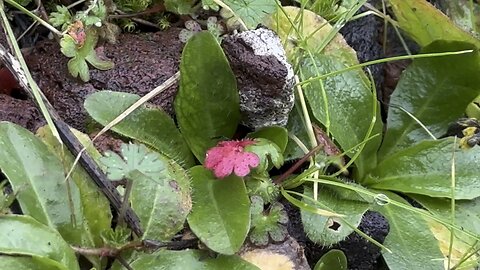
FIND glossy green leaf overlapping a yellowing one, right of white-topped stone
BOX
[301,55,381,177]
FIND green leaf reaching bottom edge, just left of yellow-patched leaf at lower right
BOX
[372,192,444,270]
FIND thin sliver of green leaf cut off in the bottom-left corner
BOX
[0,254,68,270]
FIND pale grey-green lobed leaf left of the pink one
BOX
[100,144,165,180]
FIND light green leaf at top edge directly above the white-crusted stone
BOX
[223,0,277,29]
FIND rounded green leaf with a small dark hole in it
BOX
[300,187,369,246]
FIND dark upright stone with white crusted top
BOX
[222,28,294,129]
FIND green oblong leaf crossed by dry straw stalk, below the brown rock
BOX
[85,91,195,168]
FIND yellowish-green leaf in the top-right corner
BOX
[389,0,480,47]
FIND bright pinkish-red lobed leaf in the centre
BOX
[205,139,260,178]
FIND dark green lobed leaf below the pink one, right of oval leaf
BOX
[250,196,288,246]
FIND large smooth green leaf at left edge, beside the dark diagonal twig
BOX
[0,122,84,244]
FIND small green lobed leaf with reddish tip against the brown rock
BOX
[60,28,114,82]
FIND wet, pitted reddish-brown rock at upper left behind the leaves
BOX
[26,28,183,131]
